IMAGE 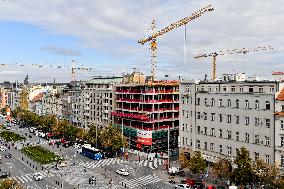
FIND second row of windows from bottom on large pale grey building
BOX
[197,126,270,146]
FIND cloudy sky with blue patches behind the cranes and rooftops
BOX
[0,0,284,82]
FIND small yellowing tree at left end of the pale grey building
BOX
[188,151,206,174]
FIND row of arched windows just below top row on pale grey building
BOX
[196,98,270,110]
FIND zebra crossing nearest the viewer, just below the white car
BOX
[122,174,162,188]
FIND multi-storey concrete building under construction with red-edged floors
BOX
[112,81,179,155]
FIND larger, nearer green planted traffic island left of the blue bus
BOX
[21,146,64,164]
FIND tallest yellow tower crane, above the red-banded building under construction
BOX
[138,4,214,81]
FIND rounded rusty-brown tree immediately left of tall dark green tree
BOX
[212,158,233,179]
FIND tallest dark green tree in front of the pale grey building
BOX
[233,147,253,184]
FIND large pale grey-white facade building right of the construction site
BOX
[180,74,284,163]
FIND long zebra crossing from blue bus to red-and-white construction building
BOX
[79,158,163,169]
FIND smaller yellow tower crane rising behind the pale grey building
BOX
[194,46,273,81]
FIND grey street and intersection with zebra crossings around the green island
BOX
[1,118,172,189]
